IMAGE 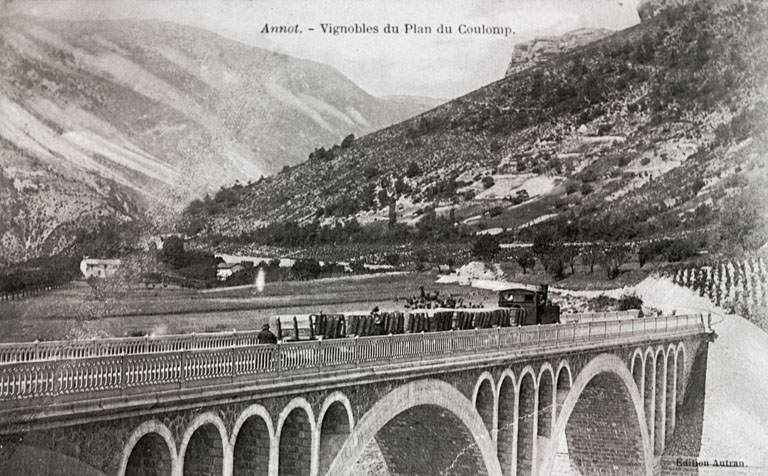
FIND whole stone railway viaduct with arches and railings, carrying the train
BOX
[0,316,711,476]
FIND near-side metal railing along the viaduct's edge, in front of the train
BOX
[0,315,706,407]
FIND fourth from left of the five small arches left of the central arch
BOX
[275,397,317,475]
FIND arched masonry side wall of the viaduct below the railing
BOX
[0,336,707,476]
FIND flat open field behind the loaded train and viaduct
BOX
[0,273,495,342]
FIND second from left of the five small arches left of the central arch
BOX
[178,412,231,476]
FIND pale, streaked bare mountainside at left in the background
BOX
[0,16,435,262]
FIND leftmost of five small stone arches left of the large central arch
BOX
[117,420,177,476]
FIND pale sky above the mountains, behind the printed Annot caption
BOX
[0,0,639,99]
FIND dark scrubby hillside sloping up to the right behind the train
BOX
[184,0,768,253]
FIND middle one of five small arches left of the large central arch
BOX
[229,404,275,476]
